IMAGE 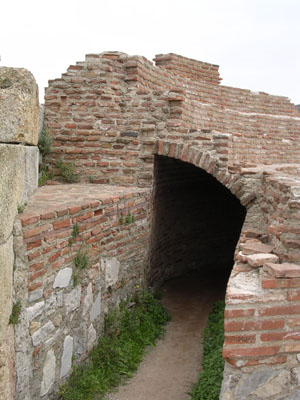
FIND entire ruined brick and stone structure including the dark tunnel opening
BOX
[0,52,300,400]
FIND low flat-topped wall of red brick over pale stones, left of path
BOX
[14,185,150,400]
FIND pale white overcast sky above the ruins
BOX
[0,0,300,104]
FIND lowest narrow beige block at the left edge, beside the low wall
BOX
[0,237,14,346]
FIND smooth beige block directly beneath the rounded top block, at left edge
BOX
[0,144,25,243]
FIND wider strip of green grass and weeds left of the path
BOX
[60,291,169,400]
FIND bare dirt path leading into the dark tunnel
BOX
[107,274,226,400]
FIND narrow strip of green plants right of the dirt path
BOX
[190,301,225,400]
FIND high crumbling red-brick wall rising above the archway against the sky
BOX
[45,52,300,186]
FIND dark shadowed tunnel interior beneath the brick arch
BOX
[149,155,246,286]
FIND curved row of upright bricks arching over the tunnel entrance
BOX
[154,140,256,208]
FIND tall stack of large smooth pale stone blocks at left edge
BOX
[0,67,38,400]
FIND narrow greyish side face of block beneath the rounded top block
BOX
[23,146,39,203]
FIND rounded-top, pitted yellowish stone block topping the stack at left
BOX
[0,67,39,145]
